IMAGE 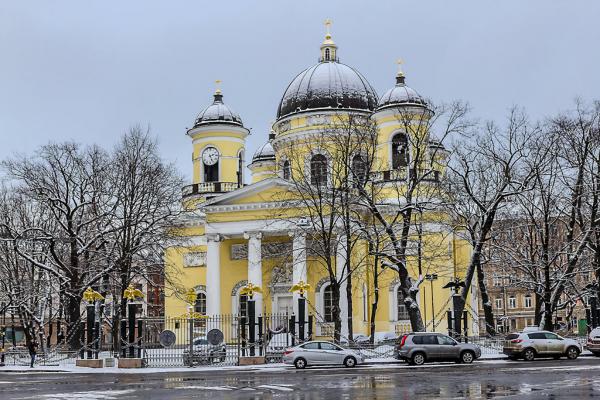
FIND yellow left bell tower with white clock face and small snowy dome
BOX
[183,81,249,205]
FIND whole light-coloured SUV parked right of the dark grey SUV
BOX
[502,331,582,361]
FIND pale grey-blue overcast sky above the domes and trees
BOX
[0,0,600,177]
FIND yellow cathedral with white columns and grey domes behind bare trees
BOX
[165,20,477,337]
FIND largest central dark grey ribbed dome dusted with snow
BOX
[277,61,377,118]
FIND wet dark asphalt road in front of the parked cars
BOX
[0,358,600,400]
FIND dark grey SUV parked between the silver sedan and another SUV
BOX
[396,332,481,365]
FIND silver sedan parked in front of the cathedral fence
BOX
[283,341,365,369]
